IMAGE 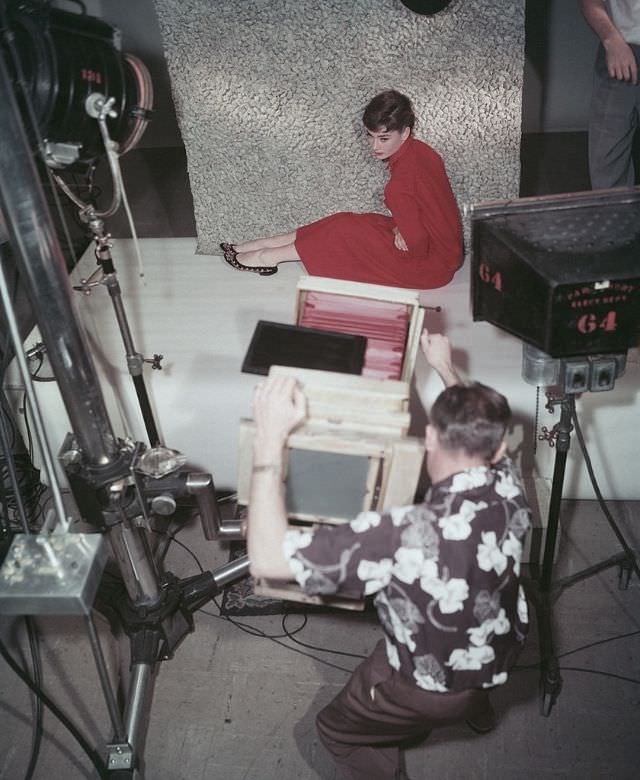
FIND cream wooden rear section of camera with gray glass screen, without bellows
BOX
[238,366,424,609]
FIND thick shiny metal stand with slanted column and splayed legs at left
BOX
[0,57,249,778]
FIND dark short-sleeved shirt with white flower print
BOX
[284,458,530,692]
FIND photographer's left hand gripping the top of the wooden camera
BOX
[253,376,307,450]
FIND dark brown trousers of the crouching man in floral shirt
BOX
[316,640,490,780]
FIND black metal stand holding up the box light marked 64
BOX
[531,393,640,716]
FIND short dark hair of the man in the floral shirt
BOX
[429,382,511,460]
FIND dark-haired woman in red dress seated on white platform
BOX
[220,90,463,289]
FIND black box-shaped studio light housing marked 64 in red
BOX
[471,187,640,358]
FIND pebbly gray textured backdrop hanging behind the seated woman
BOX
[155,0,525,254]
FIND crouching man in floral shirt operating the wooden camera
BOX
[248,332,529,780]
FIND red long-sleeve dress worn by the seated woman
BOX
[295,137,463,290]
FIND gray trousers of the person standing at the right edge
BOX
[589,44,640,189]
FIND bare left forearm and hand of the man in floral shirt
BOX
[247,376,306,580]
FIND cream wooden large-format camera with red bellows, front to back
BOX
[238,276,424,609]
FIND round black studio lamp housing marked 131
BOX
[0,3,153,169]
